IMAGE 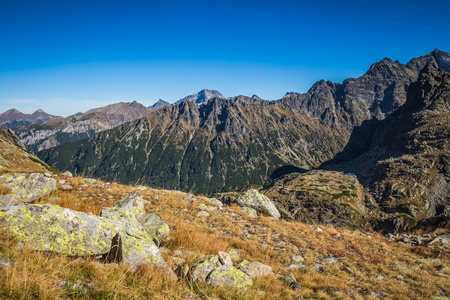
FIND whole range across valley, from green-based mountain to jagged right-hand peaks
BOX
[39,49,450,197]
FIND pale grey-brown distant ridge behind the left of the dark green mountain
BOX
[14,101,150,152]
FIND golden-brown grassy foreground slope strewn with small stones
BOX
[0,175,450,299]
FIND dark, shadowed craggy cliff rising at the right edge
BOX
[325,62,450,232]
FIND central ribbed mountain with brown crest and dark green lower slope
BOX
[39,97,343,193]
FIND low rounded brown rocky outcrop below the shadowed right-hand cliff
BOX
[261,170,370,228]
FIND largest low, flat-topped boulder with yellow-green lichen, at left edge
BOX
[0,204,118,255]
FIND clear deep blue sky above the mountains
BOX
[0,0,450,116]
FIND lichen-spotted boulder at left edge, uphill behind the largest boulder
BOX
[0,173,56,205]
